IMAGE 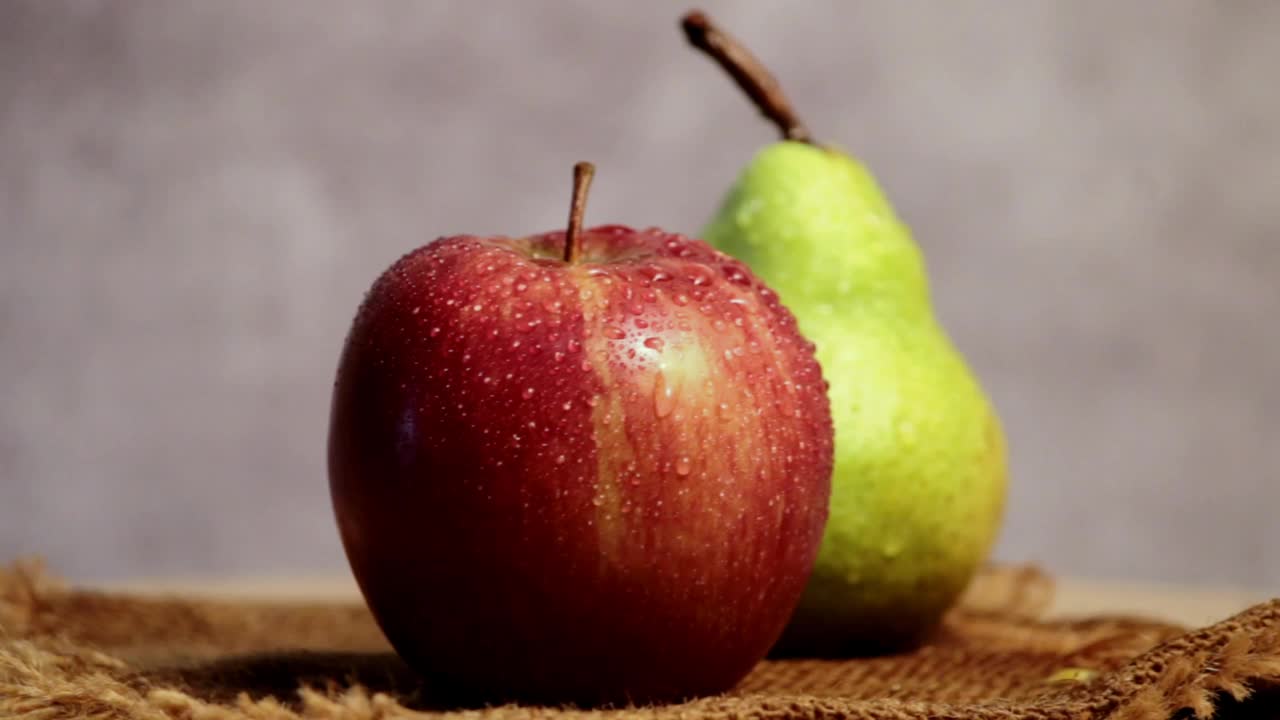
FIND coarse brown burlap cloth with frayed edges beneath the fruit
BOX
[0,564,1280,720]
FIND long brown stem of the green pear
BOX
[680,10,813,143]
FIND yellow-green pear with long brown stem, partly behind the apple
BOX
[684,13,1006,653]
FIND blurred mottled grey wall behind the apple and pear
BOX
[0,0,1280,588]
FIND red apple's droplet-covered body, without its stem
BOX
[329,225,833,705]
